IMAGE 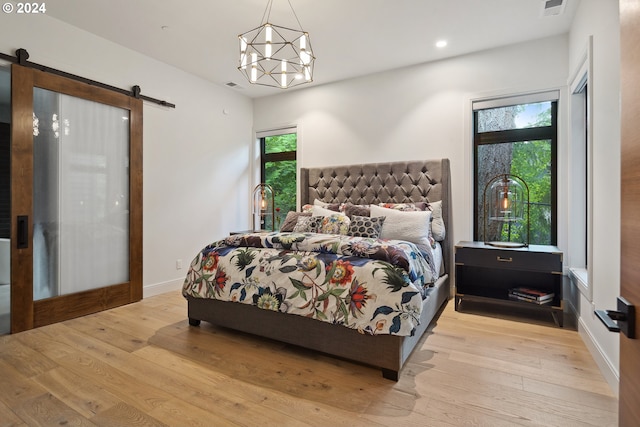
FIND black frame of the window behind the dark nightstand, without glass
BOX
[472,95,559,245]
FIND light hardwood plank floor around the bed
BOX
[0,292,617,427]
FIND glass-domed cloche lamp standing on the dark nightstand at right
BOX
[483,174,530,248]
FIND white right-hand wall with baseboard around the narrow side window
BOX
[568,0,620,392]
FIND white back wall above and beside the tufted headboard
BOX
[254,36,567,260]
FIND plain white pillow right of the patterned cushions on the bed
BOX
[371,205,431,245]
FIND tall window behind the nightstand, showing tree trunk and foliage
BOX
[473,92,558,245]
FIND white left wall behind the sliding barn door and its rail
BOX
[0,10,253,296]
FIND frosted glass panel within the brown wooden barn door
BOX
[33,88,129,300]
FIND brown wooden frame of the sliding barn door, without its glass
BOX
[11,64,142,333]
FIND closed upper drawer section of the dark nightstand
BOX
[455,247,562,273]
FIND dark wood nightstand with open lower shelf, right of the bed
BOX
[455,242,564,327]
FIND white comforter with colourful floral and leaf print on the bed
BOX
[182,232,438,335]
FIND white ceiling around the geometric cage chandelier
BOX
[26,0,579,97]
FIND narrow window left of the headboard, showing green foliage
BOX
[260,129,298,229]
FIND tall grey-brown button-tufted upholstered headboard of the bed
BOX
[300,159,453,272]
